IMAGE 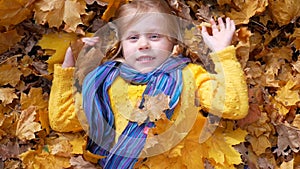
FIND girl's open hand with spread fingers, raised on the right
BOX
[202,18,235,52]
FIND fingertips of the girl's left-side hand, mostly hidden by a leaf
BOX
[62,37,99,68]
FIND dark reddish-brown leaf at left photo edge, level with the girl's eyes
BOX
[0,29,22,53]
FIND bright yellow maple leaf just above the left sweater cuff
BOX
[37,33,77,73]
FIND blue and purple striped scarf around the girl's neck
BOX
[82,57,190,169]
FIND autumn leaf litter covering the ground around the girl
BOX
[0,0,300,169]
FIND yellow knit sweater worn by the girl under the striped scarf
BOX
[49,46,248,168]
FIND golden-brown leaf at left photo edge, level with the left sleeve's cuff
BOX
[0,57,22,87]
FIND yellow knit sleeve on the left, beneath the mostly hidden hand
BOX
[48,64,82,132]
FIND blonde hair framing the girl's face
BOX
[103,0,182,62]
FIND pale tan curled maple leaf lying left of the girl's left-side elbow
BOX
[16,106,41,140]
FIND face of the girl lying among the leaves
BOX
[121,15,174,73]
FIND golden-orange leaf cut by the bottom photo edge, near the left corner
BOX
[20,150,71,169]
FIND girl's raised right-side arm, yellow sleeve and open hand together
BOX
[197,18,249,119]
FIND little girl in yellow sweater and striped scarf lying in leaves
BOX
[49,0,248,169]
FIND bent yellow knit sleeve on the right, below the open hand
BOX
[196,46,249,119]
